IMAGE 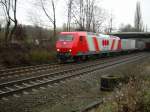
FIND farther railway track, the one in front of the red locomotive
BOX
[0,54,144,84]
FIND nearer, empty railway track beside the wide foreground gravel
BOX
[0,54,148,98]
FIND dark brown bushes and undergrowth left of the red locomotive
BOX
[0,25,59,67]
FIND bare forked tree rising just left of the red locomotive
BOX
[40,0,56,37]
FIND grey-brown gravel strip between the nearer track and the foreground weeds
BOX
[0,53,150,112]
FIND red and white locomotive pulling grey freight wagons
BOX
[56,32,143,62]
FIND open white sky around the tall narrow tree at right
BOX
[101,0,150,27]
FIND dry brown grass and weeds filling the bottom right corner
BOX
[95,55,150,112]
